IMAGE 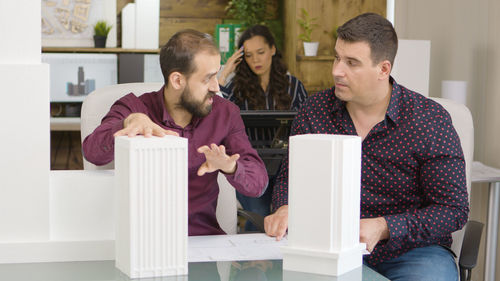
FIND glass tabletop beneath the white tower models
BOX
[0,260,388,281]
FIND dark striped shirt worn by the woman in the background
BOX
[220,75,307,111]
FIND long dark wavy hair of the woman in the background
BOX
[233,25,292,110]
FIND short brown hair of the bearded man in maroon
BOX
[160,29,219,85]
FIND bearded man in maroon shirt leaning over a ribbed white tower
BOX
[83,30,268,235]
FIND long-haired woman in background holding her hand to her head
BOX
[219,25,307,231]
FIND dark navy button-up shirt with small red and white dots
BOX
[273,78,469,265]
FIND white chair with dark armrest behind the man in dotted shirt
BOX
[431,98,483,281]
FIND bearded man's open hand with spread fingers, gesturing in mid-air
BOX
[198,143,240,176]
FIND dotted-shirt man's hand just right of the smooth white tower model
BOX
[359,217,390,253]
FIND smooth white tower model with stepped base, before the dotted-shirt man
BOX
[282,135,365,276]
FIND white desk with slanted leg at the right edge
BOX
[472,162,500,281]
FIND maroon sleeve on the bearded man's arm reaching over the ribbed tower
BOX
[82,94,148,166]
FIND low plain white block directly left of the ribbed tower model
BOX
[50,170,115,241]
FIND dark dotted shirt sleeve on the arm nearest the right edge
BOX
[385,113,469,249]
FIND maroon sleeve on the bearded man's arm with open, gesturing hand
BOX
[222,104,269,197]
